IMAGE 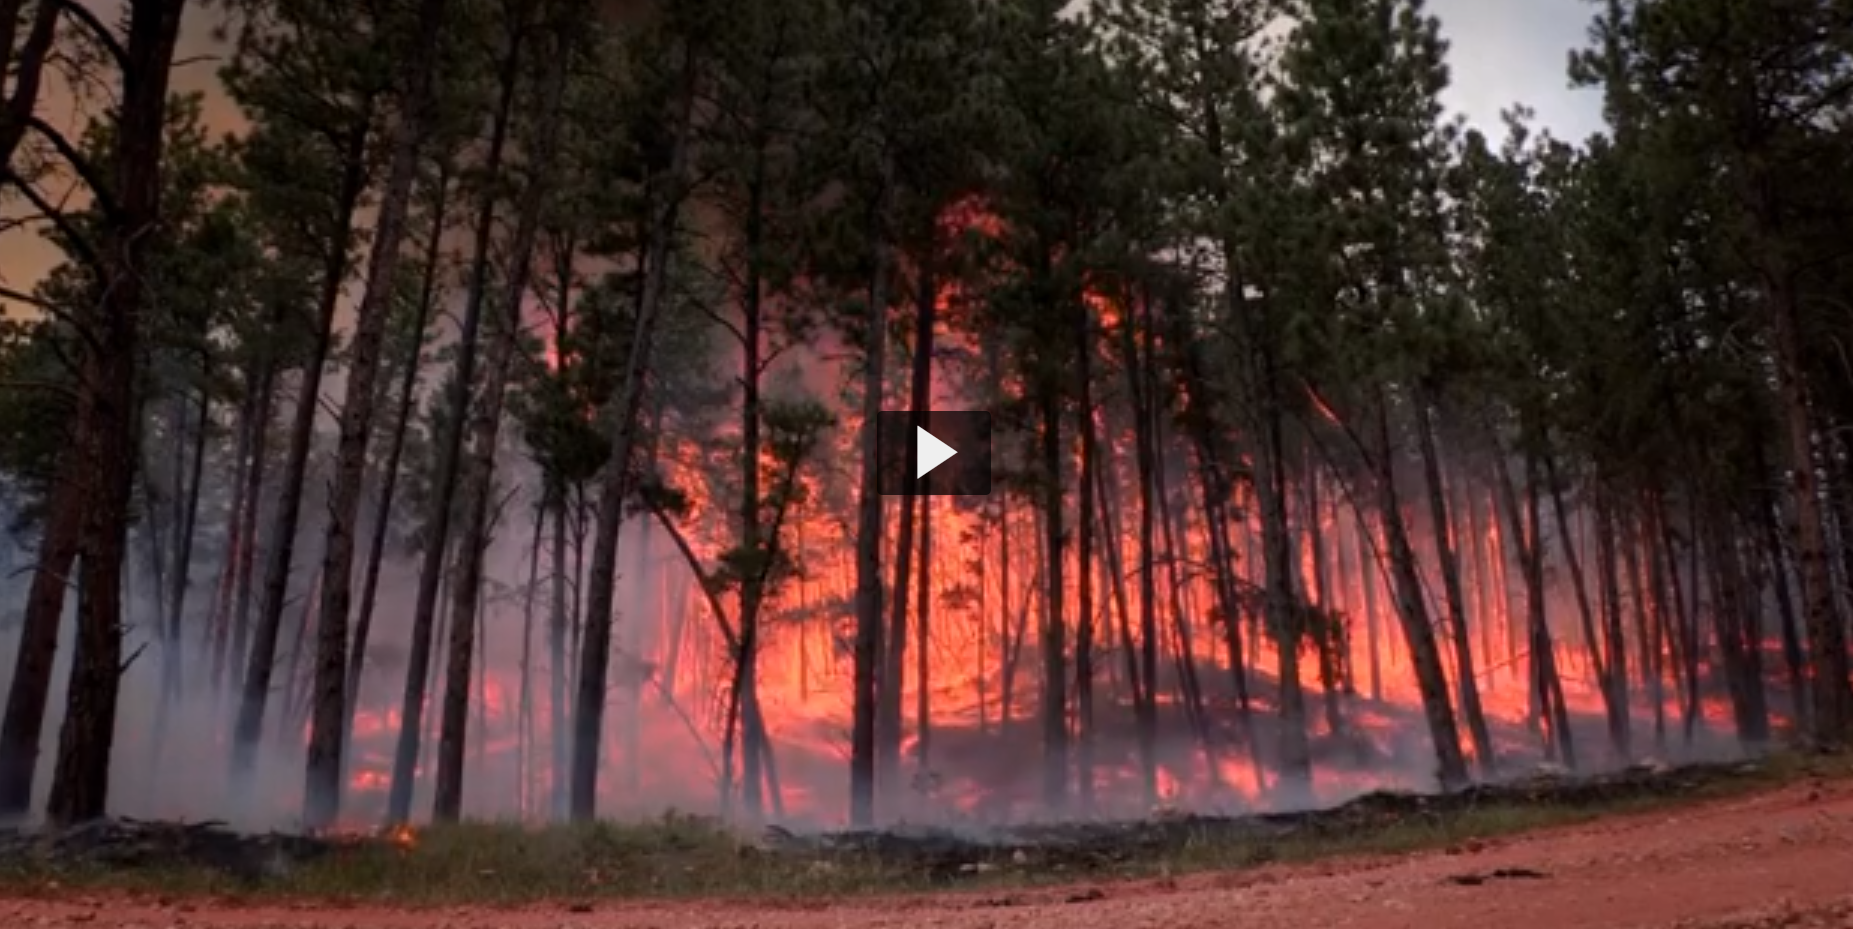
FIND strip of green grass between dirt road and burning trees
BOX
[0,755,1853,905]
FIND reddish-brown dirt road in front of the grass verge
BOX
[0,783,1853,929]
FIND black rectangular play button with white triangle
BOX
[875,410,991,495]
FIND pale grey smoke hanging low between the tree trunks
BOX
[0,437,1781,829]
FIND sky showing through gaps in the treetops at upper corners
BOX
[0,0,1601,300]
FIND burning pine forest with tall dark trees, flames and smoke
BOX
[0,0,1853,875]
